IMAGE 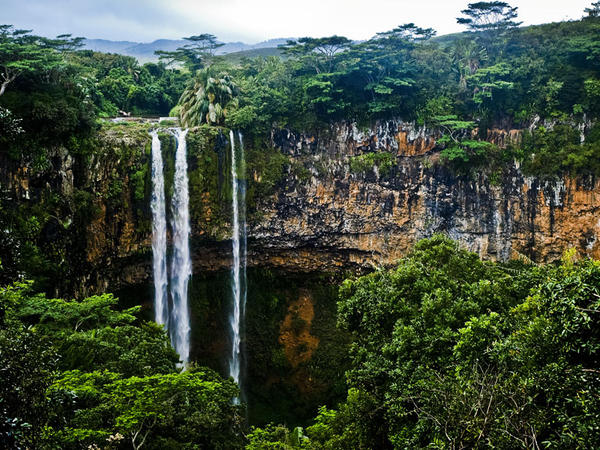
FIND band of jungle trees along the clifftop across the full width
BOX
[0,2,600,175]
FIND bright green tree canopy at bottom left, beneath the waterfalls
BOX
[50,367,242,450]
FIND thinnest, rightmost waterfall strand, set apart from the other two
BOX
[229,131,246,402]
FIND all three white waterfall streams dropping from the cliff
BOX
[151,128,247,403]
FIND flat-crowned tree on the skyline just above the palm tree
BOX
[154,34,225,73]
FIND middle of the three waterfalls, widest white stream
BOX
[170,128,192,364]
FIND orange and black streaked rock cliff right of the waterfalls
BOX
[255,122,600,270]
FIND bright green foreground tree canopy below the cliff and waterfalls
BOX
[0,236,600,449]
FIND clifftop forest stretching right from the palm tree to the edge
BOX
[231,14,600,130]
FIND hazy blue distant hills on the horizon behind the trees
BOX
[84,38,291,63]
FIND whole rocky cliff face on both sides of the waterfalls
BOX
[0,121,600,295]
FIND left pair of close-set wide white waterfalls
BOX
[151,128,192,364]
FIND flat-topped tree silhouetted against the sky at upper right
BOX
[456,1,521,32]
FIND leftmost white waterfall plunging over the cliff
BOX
[150,130,169,325]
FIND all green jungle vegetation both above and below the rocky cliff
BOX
[0,2,600,450]
